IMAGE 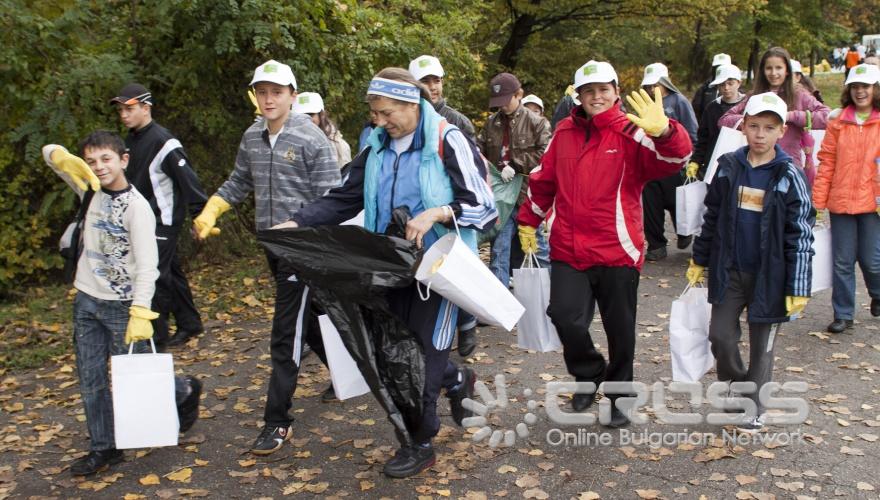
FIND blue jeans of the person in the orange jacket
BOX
[831,212,880,320]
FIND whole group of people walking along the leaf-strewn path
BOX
[44,47,880,477]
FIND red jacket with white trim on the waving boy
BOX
[517,101,692,270]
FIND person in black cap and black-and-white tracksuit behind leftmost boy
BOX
[110,83,207,350]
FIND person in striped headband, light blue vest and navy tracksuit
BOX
[286,68,498,477]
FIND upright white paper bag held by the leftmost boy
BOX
[110,339,180,450]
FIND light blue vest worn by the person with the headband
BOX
[364,99,477,253]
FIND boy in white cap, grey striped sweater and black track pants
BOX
[193,60,340,455]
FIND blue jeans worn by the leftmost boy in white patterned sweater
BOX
[73,292,188,451]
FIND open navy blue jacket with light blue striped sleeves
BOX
[693,145,816,323]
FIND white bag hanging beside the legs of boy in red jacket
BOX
[513,254,562,352]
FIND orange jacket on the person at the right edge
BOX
[813,106,880,214]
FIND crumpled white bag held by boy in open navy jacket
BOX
[669,287,715,382]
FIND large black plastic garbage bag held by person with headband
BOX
[257,224,425,446]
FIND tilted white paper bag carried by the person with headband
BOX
[416,220,525,331]
